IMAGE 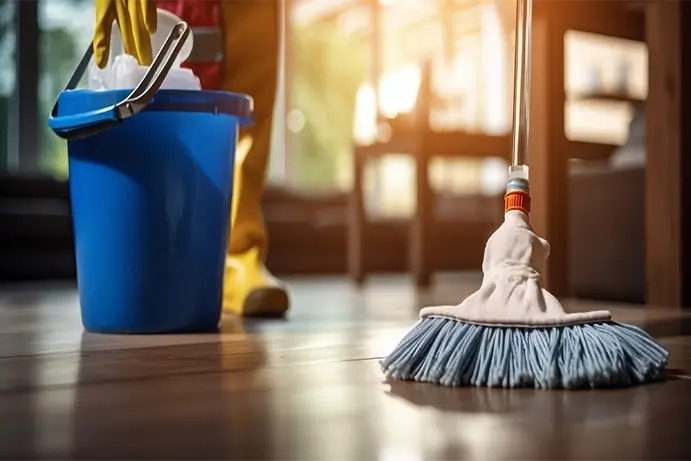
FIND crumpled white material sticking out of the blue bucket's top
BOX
[88,8,202,90]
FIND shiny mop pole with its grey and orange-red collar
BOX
[504,0,533,215]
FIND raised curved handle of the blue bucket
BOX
[48,21,190,140]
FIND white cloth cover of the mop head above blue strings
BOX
[420,211,612,328]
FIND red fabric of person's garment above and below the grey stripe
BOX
[156,0,223,90]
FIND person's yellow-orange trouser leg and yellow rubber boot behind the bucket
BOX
[220,0,289,317]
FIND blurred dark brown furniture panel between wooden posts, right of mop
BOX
[569,161,645,302]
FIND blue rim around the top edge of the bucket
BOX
[57,88,254,124]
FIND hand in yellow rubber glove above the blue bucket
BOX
[94,0,157,69]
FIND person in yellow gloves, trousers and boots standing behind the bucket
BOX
[94,0,289,317]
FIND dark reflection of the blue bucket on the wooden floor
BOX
[67,322,272,461]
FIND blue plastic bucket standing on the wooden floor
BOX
[49,22,252,333]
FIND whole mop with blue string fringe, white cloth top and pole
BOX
[381,0,669,389]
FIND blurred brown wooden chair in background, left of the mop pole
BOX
[348,62,511,286]
